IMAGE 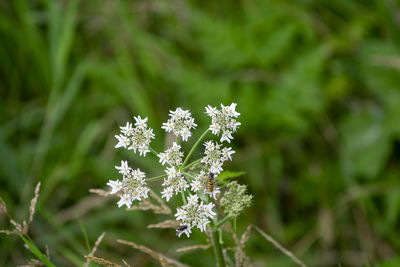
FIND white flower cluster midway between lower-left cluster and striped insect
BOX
[161,167,189,201]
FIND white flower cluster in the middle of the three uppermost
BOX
[161,108,197,141]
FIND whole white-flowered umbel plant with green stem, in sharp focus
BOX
[107,103,252,266]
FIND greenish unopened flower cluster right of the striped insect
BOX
[220,181,253,218]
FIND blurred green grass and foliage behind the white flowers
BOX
[0,0,400,266]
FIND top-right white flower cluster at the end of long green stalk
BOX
[206,103,240,143]
